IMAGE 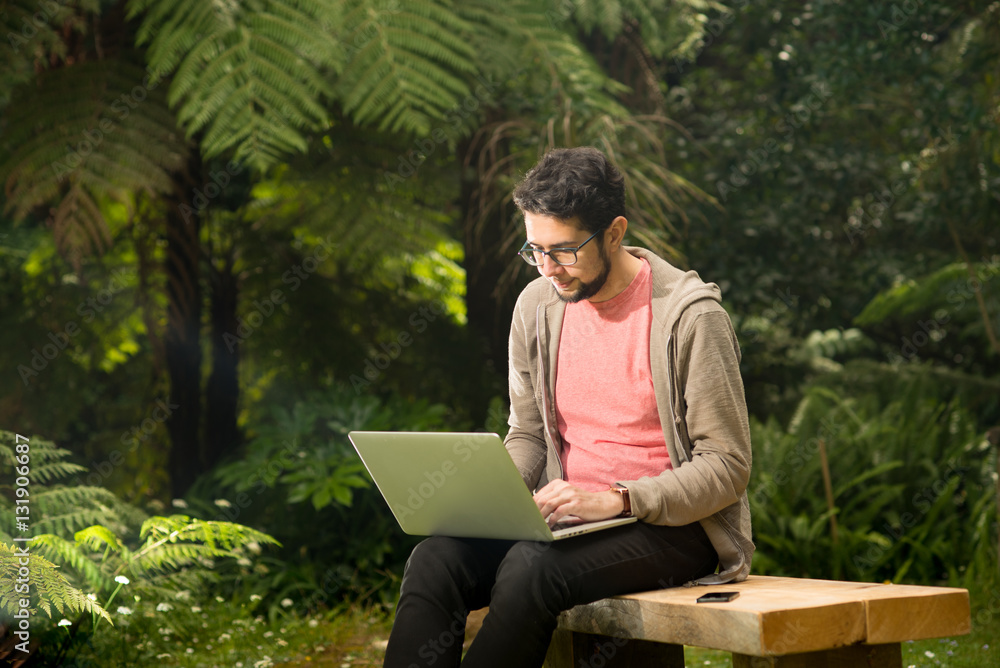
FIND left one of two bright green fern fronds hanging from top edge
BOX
[128,0,340,169]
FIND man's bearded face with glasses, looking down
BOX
[524,212,611,303]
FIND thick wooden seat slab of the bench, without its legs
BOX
[559,576,971,656]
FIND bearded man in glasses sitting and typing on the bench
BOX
[385,148,754,668]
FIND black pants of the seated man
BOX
[384,522,719,668]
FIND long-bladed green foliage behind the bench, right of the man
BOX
[750,371,997,586]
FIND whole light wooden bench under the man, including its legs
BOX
[545,576,971,668]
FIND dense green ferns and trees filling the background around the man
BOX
[0,0,1000,666]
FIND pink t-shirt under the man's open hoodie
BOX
[555,260,670,492]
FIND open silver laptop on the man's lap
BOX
[348,431,636,542]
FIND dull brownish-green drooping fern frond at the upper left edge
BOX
[0,58,186,270]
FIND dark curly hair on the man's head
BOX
[514,146,625,234]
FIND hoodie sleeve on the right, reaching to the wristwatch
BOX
[623,302,751,526]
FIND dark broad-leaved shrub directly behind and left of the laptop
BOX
[205,386,462,617]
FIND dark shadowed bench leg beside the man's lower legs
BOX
[545,629,684,668]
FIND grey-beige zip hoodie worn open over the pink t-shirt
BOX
[505,248,754,584]
